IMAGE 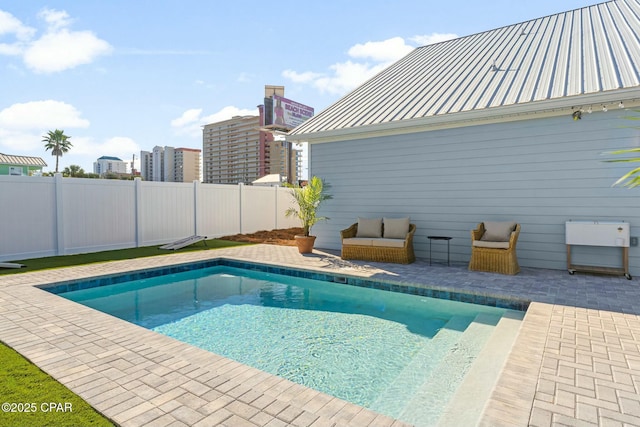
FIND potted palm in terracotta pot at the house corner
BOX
[285,176,332,254]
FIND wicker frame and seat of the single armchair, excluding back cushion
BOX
[469,222,520,274]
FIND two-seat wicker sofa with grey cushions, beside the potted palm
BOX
[340,218,416,264]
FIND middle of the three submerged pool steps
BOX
[398,313,501,426]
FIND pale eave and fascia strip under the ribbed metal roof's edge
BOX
[287,87,640,144]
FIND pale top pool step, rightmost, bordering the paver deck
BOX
[438,311,525,427]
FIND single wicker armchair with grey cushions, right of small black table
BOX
[469,222,520,274]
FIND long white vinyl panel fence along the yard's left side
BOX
[0,174,299,262]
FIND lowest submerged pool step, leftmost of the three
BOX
[369,316,473,418]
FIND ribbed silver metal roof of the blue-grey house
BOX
[290,0,640,140]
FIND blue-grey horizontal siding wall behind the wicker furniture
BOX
[310,109,640,275]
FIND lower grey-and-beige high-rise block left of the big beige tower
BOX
[140,146,201,182]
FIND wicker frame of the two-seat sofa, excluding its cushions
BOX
[340,223,416,264]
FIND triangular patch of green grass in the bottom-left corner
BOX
[0,343,114,427]
